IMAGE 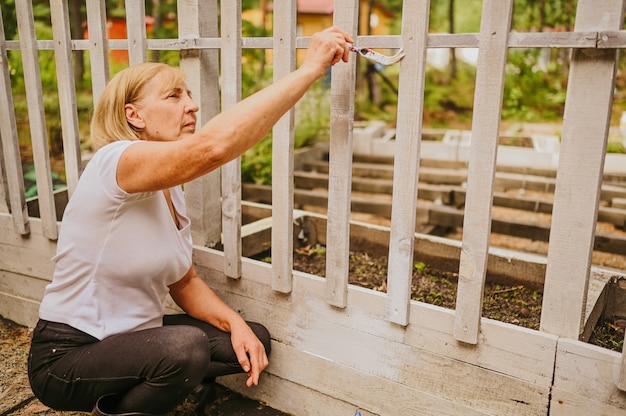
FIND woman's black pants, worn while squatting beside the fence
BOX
[28,315,270,414]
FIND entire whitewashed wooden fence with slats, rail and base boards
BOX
[0,0,626,415]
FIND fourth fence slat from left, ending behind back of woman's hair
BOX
[87,0,110,106]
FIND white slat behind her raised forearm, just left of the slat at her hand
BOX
[272,0,297,293]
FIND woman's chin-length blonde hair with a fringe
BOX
[90,62,185,151]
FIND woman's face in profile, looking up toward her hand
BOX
[125,74,198,141]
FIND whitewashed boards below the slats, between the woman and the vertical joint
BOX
[194,250,556,414]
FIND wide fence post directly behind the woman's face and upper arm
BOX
[178,0,222,247]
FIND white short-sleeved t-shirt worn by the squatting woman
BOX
[39,141,192,339]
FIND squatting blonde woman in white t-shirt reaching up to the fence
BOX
[28,28,352,415]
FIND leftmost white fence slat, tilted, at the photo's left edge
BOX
[0,6,30,235]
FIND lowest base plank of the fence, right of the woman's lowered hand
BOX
[220,343,494,416]
